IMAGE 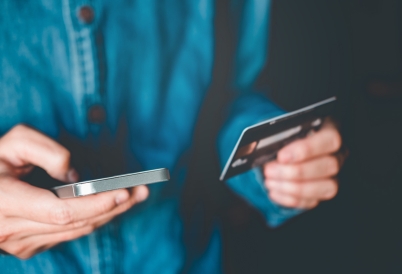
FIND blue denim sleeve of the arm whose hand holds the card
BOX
[218,0,301,227]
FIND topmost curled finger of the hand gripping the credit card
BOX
[278,120,342,164]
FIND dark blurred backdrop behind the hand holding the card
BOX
[184,0,402,273]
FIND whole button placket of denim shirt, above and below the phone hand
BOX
[63,0,120,273]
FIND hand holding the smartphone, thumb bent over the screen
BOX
[0,125,148,259]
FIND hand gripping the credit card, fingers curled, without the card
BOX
[263,120,345,209]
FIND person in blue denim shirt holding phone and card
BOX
[0,0,341,273]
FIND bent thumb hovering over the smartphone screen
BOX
[0,125,78,182]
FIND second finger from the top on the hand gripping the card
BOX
[264,156,340,181]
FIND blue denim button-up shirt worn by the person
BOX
[0,0,297,273]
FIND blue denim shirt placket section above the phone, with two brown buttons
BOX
[63,0,106,137]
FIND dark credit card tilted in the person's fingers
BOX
[220,97,336,181]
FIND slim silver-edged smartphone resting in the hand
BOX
[50,168,170,198]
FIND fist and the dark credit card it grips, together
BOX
[220,97,347,209]
